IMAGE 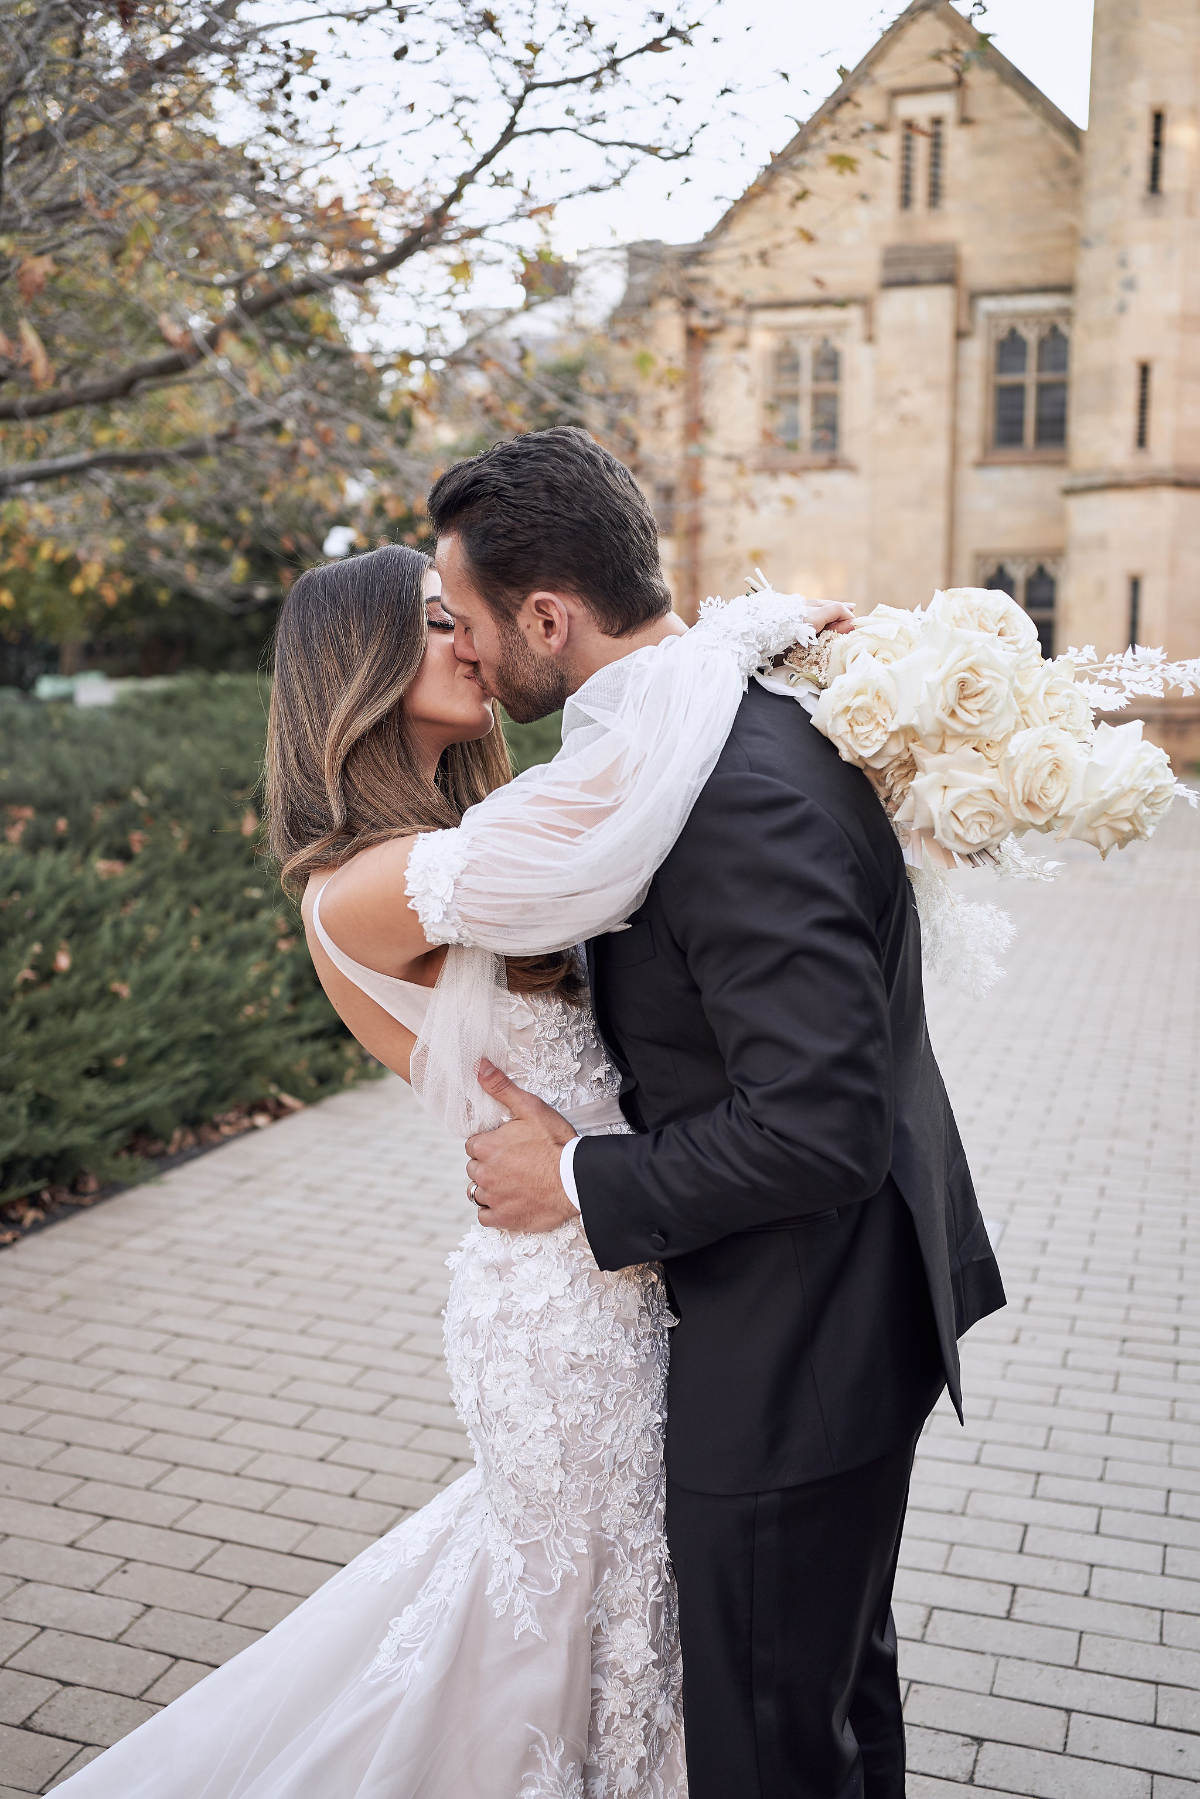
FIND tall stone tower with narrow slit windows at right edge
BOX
[1060,0,1200,730]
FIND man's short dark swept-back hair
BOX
[428,425,671,637]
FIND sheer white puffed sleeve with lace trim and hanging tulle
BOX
[407,592,815,1135]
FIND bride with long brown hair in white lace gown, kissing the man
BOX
[59,547,842,1799]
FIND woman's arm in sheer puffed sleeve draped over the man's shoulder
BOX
[320,594,851,979]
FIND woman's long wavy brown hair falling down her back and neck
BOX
[263,543,583,998]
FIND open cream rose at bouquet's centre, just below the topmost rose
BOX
[892,630,1016,750]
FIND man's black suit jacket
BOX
[574,684,1004,1493]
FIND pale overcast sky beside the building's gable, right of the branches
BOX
[556,0,1092,250]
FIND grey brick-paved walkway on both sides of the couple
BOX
[0,810,1200,1799]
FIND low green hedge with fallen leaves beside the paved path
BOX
[0,675,558,1204]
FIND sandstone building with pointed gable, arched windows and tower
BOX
[613,0,1200,754]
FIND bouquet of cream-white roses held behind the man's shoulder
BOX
[784,586,1200,867]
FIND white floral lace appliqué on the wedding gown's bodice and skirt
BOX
[353,995,685,1799]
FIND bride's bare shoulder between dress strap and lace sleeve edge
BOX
[300,831,430,977]
